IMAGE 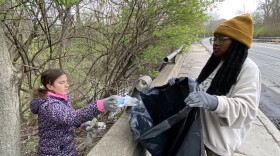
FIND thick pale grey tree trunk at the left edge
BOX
[0,23,21,156]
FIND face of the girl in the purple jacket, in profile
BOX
[47,74,69,95]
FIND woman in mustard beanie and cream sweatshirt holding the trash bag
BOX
[185,14,261,156]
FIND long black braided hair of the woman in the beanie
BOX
[197,40,248,95]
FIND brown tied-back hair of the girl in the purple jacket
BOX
[32,69,66,98]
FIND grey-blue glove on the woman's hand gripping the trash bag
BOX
[184,91,218,111]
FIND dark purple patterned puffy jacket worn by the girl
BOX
[30,95,101,156]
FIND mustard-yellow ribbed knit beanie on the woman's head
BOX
[214,13,254,48]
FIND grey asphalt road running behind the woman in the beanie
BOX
[201,38,280,130]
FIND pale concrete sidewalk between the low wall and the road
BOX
[177,44,280,156]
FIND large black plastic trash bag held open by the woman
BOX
[129,78,205,156]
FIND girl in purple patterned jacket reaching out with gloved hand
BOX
[30,69,117,156]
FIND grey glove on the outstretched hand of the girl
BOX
[103,95,122,112]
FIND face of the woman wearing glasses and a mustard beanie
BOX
[213,34,232,60]
